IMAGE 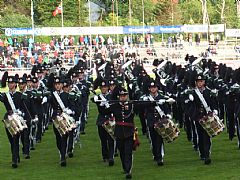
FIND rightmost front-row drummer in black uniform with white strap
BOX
[189,74,217,164]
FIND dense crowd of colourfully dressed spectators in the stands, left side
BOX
[0,34,153,68]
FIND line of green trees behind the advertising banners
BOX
[0,0,240,28]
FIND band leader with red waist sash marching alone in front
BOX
[106,88,155,179]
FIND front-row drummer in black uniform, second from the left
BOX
[48,77,75,166]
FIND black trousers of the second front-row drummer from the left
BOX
[53,125,68,161]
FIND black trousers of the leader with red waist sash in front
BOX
[116,136,133,173]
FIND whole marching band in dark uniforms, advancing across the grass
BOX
[0,51,240,179]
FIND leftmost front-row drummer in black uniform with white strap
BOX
[0,76,23,168]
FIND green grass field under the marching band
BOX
[0,100,240,180]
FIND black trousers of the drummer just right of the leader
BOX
[148,126,164,161]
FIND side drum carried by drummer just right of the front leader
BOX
[154,117,180,143]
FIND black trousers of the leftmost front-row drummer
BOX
[5,128,20,164]
